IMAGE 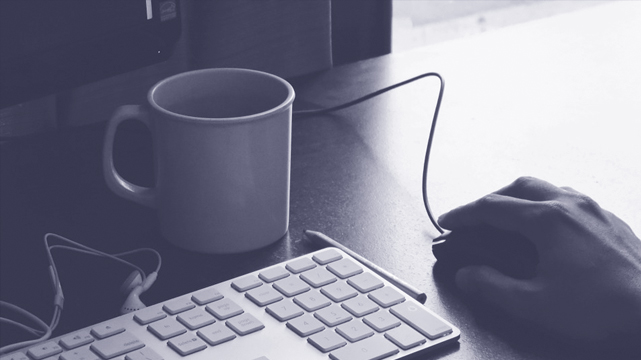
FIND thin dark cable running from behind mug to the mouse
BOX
[292,72,445,234]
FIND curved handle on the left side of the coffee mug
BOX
[102,105,156,208]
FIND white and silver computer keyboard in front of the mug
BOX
[0,248,460,360]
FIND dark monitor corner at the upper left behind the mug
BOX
[0,0,180,107]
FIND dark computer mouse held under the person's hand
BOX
[432,225,539,279]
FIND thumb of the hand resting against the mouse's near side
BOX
[456,266,535,318]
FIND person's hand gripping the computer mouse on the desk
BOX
[439,177,641,341]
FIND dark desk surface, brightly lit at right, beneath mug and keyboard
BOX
[0,2,641,359]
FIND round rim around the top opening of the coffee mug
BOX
[147,68,296,123]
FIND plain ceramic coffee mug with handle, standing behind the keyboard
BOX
[103,69,294,253]
